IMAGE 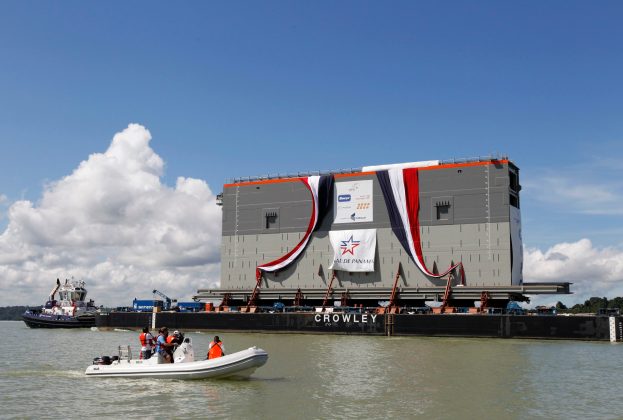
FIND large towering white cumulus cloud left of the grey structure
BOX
[0,124,221,306]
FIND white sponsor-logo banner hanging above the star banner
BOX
[333,180,373,223]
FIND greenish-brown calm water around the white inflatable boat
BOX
[0,321,623,419]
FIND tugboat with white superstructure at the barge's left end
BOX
[22,279,97,328]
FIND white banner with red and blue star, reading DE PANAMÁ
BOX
[329,229,376,272]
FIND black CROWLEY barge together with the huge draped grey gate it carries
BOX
[96,156,622,341]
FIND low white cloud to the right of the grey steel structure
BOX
[524,239,623,303]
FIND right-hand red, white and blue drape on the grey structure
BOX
[376,168,465,283]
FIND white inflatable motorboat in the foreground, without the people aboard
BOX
[85,337,268,379]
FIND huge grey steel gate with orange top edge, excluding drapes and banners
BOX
[196,157,569,306]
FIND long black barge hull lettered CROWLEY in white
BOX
[96,312,622,341]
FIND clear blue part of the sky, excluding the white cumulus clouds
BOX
[0,1,623,303]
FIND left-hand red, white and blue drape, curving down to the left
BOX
[255,176,334,284]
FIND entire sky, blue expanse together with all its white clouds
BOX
[0,0,623,306]
